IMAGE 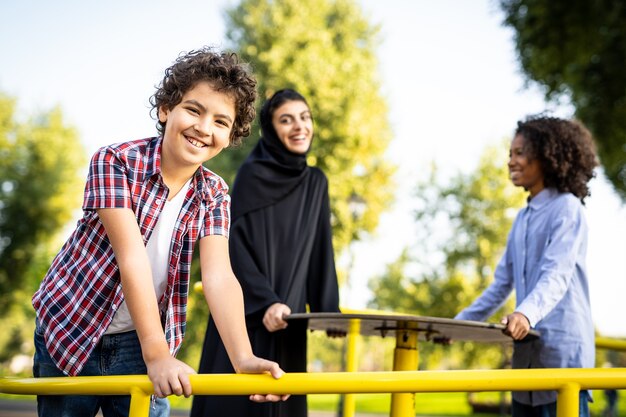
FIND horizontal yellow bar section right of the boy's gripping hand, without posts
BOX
[190,368,626,395]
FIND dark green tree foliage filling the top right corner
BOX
[500,0,626,201]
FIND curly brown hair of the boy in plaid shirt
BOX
[150,47,257,146]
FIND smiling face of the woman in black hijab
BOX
[272,101,313,154]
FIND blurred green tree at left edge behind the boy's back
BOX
[0,94,85,316]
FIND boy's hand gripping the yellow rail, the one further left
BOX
[146,355,196,398]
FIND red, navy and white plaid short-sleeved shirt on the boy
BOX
[33,138,230,375]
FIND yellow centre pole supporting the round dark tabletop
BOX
[390,323,419,417]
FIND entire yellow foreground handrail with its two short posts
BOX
[0,368,626,417]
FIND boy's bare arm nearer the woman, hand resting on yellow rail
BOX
[200,235,289,402]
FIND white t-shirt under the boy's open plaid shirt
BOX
[104,179,191,334]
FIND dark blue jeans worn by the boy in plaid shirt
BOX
[33,326,170,417]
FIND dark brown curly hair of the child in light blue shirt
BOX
[515,115,598,203]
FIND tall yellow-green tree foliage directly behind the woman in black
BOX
[222,0,395,253]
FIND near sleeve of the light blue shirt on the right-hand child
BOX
[516,202,587,327]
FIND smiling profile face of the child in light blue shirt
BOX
[509,135,544,197]
